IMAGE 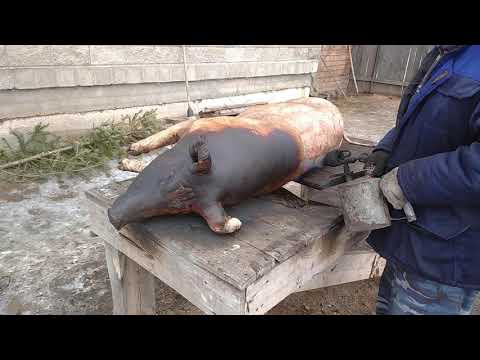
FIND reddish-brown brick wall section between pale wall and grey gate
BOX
[312,45,351,96]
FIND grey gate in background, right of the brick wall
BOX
[352,45,433,93]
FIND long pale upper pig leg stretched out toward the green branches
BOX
[128,120,193,155]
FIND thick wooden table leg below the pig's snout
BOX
[104,242,155,315]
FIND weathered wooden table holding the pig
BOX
[86,141,383,314]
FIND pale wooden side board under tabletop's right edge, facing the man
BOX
[245,225,367,314]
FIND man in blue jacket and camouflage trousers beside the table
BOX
[368,45,480,314]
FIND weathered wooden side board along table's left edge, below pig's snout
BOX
[86,198,245,314]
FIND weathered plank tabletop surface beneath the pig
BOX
[87,180,342,289]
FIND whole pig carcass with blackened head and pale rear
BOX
[108,98,343,234]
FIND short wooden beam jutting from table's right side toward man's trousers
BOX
[296,251,385,292]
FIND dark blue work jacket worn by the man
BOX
[368,45,480,289]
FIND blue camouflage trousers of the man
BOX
[376,261,478,315]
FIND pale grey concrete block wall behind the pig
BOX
[0,45,352,135]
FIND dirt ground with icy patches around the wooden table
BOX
[0,95,480,315]
